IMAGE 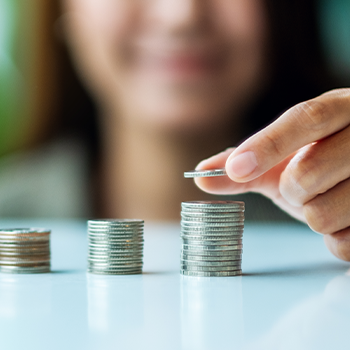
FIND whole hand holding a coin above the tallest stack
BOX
[195,89,350,261]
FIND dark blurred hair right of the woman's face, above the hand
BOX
[243,0,337,133]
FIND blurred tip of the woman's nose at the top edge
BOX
[151,0,207,34]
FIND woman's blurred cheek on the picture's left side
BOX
[64,0,137,103]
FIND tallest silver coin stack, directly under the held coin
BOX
[180,201,244,277]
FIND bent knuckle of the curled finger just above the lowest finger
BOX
[303,195,337,234]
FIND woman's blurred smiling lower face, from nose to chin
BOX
[64,0,267,131]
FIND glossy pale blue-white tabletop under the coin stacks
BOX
[0,220,350,350]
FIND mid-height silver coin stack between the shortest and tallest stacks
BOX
[88,219,144,275]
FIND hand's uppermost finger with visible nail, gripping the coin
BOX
[226,89,350,182]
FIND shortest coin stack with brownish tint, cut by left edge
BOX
[0,228,51,273]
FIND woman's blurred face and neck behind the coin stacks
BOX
[63,0,268,220]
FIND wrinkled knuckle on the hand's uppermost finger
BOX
[295,99,332,132]
